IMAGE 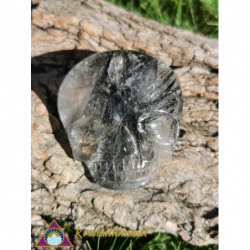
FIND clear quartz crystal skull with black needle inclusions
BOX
[58,51,182,190]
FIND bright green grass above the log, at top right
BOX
[107,0,219,39]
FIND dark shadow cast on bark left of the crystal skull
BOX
[30,49,95,182]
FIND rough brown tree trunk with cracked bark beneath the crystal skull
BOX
[30,0,219,246]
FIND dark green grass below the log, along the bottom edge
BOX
[40,214,219,250]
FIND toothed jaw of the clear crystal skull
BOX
[73,143,173,190]
